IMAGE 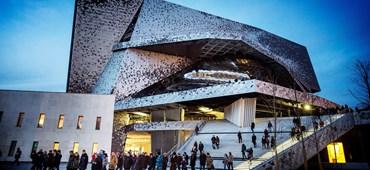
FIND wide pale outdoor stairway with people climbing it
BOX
[177,112,370,169]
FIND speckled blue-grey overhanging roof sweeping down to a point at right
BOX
[113,0,320,92]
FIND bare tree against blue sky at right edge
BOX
[350,60,370,108]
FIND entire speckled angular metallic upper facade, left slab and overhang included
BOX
[68,0,320,101]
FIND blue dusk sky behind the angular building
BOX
[0,0,370,106]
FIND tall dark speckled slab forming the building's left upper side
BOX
[67,0,142,93]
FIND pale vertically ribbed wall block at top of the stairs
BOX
[224,98,256,127]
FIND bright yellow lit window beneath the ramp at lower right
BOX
[327,142,346,163]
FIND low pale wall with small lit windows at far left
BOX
[0,91,114,161]
